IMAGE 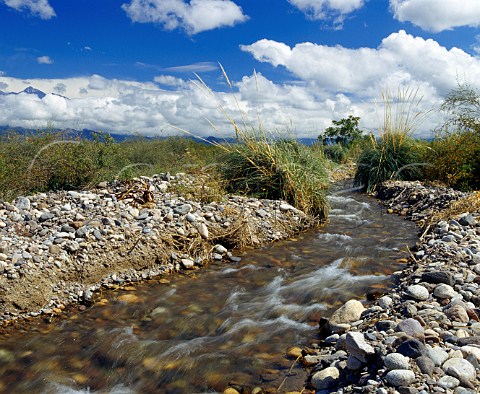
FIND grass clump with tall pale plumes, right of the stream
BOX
[355,89,426,193]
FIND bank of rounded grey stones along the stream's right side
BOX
[300,182,480,394]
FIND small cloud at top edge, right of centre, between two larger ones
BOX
[288,0,364,27]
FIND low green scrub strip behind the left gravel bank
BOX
[0,132,218,200]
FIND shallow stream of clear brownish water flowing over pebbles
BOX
[0,183,416,394]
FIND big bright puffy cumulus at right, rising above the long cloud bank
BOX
[241,30,480,96]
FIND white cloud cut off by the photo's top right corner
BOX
[390,0,480,33]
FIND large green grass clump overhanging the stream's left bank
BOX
[190,68,328,221]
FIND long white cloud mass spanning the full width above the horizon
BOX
[0,31,480,137]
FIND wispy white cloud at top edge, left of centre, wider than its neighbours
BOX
[122,0,248,34]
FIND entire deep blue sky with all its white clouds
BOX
[0,0,480,138]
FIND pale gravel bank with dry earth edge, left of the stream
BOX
[0,174,313,324]
